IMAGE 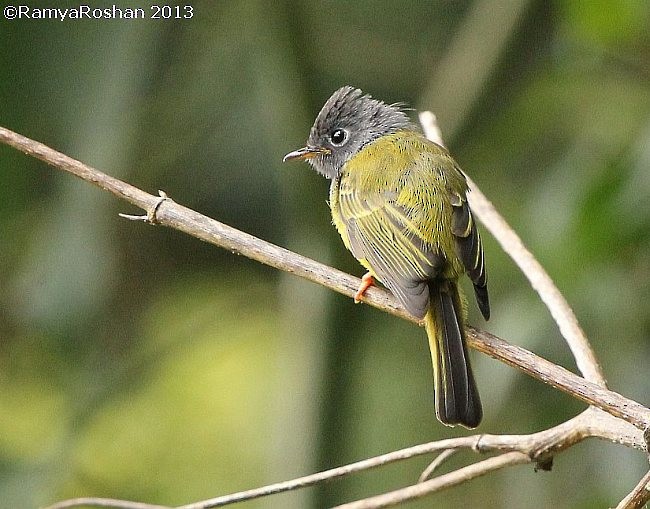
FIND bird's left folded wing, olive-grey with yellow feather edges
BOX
[339,185,442,318]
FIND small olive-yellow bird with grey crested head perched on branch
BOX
[284,86,490,429]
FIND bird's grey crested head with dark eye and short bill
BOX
[284,86,411,179]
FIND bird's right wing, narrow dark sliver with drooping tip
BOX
[451,194,490,320]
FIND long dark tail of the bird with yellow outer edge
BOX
[424,281,483,428]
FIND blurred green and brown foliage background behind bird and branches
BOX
[0,0,650,508]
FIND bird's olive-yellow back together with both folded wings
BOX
[330,133,489,318]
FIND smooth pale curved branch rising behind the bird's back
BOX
[420,111,607,387]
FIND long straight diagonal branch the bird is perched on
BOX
[0,127,650,430]
